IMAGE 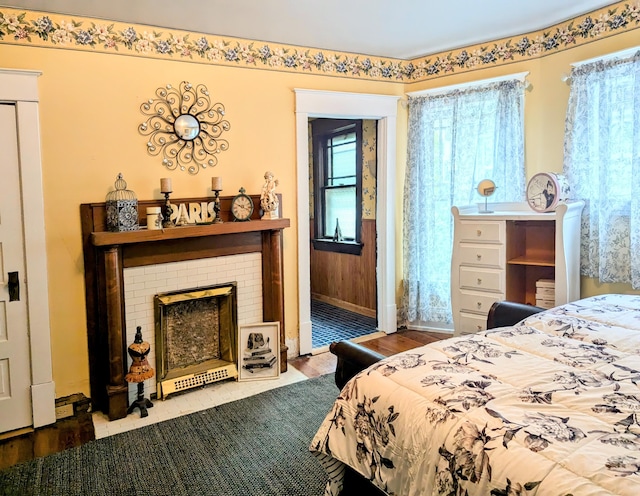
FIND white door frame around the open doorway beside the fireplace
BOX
[294,88,400,355]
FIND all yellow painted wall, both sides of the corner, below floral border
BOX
[0,3,638,397]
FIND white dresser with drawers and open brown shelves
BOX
[451,201,584,336]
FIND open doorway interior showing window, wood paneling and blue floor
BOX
[309,118,377,353]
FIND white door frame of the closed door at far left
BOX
[0,69,56,427]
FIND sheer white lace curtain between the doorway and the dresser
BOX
[400,79,525,324]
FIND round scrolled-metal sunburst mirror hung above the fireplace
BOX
[138,81,231,174]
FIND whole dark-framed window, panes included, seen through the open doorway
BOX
[311,119,362,254]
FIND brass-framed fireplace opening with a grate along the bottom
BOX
[153,282,238,399]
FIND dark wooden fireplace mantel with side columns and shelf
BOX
[80,195,290,420]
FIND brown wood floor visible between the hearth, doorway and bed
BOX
[289,330,451,377]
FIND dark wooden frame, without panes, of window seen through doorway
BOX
[311,119,363,255]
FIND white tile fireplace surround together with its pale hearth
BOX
[93,253,307,439]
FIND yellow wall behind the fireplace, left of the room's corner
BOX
[0,38,402,397]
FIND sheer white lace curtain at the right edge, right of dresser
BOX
[564,51,640,289]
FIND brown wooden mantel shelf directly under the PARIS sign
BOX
[91,219,290,246]
